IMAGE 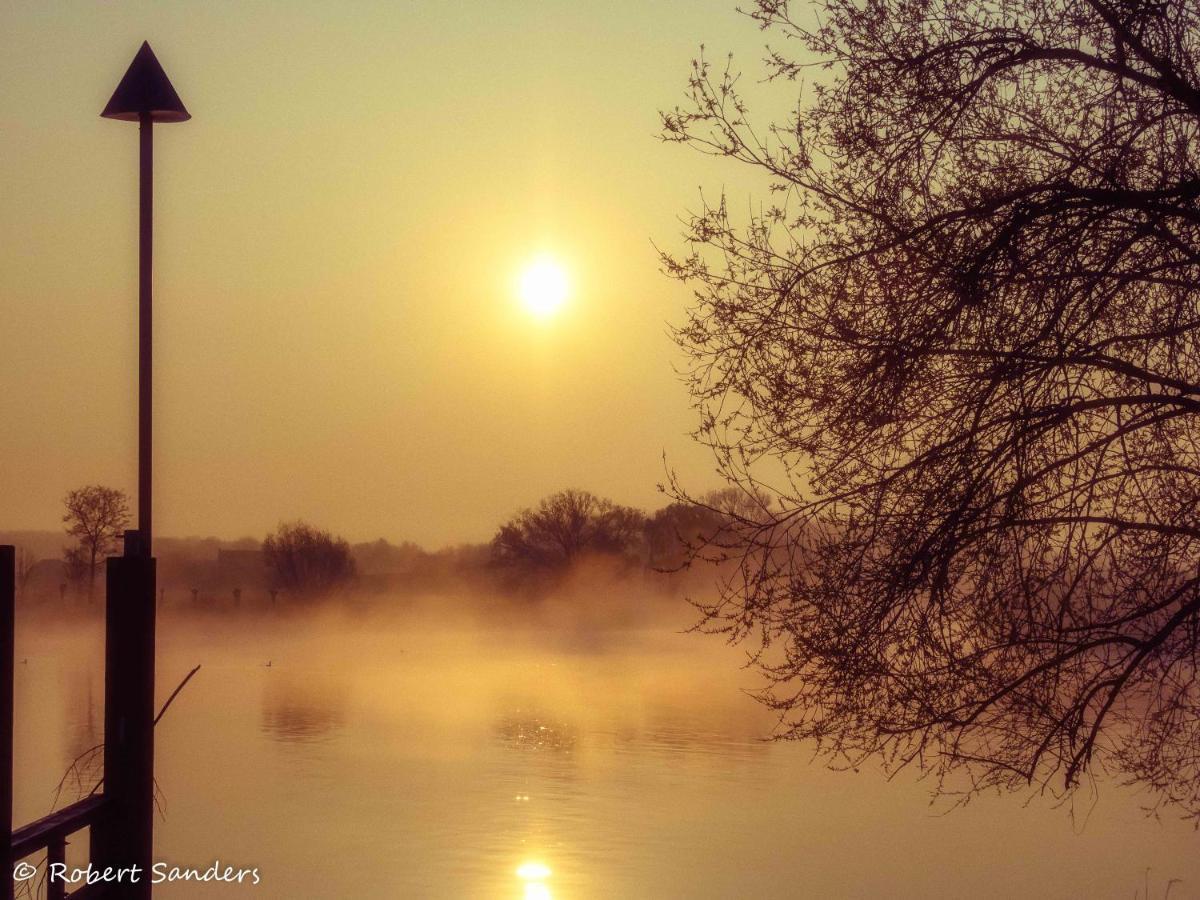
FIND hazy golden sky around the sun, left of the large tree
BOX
[0,0,763,545]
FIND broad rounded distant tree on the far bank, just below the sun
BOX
[492,490,646,568]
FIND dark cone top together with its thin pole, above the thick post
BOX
[101,42,192,556]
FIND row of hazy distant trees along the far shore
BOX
[18,485,770,601]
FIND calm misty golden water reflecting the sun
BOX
[9,602,1200,900]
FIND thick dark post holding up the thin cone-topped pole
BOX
[91,532,155,900]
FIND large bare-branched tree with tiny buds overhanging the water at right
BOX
[664,0,1200,816]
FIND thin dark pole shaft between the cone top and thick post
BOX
[138,113,154,556]
